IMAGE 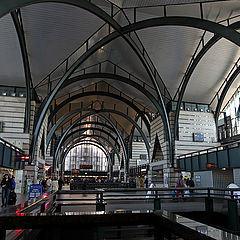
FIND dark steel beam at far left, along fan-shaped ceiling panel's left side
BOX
[11,10,32,133]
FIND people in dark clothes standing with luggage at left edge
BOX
[1,174,16,207]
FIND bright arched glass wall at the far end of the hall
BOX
[64,143,108,172]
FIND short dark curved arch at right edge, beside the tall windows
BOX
[215,66,240,125]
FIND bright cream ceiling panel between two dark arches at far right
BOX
[184,39,240,103]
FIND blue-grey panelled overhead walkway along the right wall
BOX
[177,141,240,171]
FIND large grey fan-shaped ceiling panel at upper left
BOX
[22,3,103,85]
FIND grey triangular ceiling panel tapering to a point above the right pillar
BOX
[138,26,203,96]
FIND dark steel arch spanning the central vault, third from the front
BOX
[48,91,150,132]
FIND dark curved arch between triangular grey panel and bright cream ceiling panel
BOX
[174,21,240,138]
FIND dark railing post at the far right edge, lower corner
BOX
[228,199,239,231]
